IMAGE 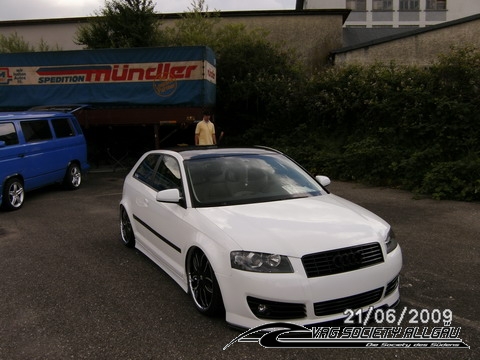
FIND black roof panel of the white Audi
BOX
[164,146,280,160]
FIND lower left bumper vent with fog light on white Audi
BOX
[247,296,307,320]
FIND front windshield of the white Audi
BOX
[185,155,322,207]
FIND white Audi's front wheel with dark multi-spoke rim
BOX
[187,249,224,316]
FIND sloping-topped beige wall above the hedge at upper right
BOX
[333,16,480,66]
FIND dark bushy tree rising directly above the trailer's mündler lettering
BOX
[75,0,160,49]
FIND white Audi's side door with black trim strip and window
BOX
[134,154,194,277]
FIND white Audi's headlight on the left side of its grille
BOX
[230,251,293,273]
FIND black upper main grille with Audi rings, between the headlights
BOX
[302,243,384,278]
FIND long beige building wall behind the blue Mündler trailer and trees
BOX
[0,10,349,68]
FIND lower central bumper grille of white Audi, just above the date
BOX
[313,287,383,316]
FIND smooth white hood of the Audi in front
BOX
[198,194,390,257]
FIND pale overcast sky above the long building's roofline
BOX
[0,0,296,21]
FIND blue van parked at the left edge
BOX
[0,111,89,210]
